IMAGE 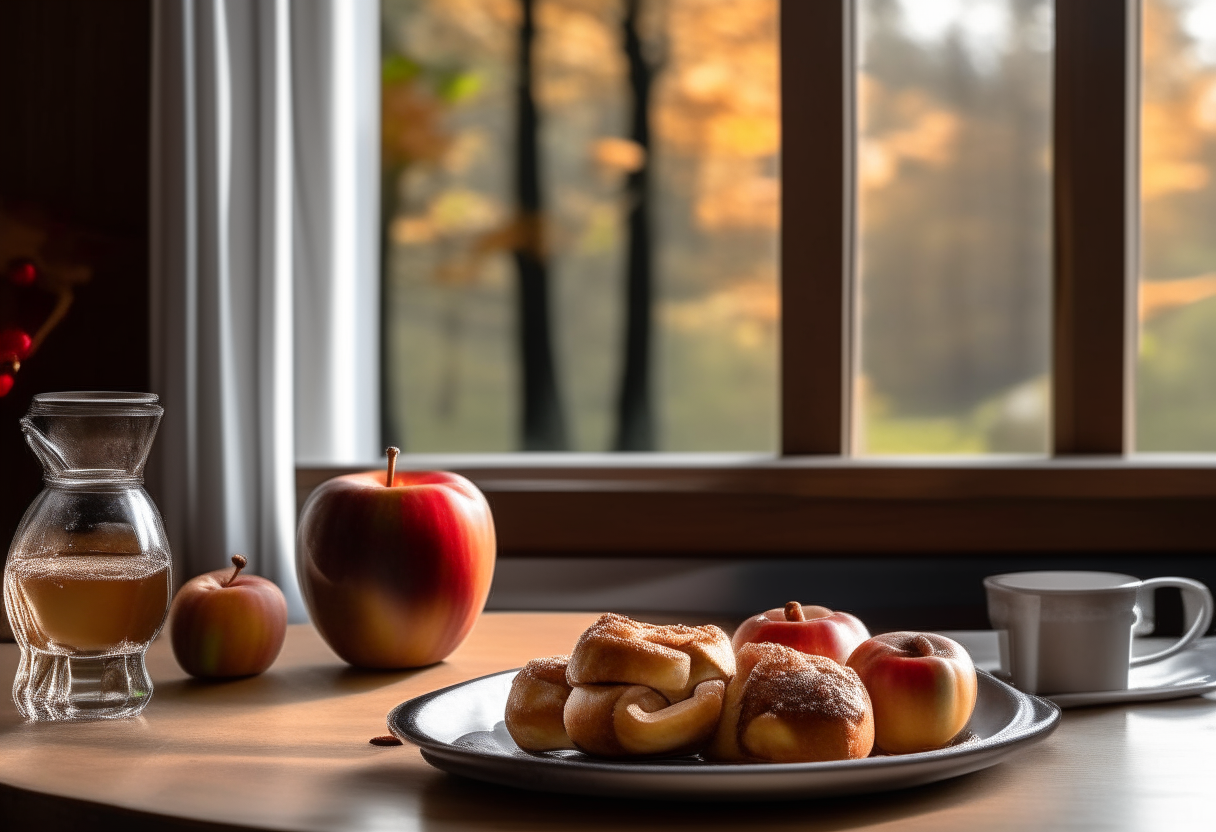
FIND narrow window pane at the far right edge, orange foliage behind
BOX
[1136,0,1216,451]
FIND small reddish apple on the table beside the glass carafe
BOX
[169,555,287,679]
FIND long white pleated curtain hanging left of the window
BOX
[148,0,379,620]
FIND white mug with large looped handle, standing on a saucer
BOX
[984,572,1212,693]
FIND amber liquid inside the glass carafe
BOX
[10,551,169,656]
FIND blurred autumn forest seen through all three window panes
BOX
[382,0,1216,454]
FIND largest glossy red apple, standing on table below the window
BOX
[295,448,495,668]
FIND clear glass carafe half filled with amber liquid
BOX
[4,393,173,720]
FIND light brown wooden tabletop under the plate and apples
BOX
[0,613,1216,832]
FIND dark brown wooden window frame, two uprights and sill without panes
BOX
[297,0,1216,558]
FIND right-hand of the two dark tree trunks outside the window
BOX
[614,0,655,450]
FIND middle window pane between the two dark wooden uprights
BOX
[857,0,1053,454]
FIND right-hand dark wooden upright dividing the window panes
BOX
[1053,0,1139,455]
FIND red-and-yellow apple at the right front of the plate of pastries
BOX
[849,633,975,754]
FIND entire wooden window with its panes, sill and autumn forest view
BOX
[352,0,1216,555]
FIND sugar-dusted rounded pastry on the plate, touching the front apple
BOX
[705,642,874,763]
